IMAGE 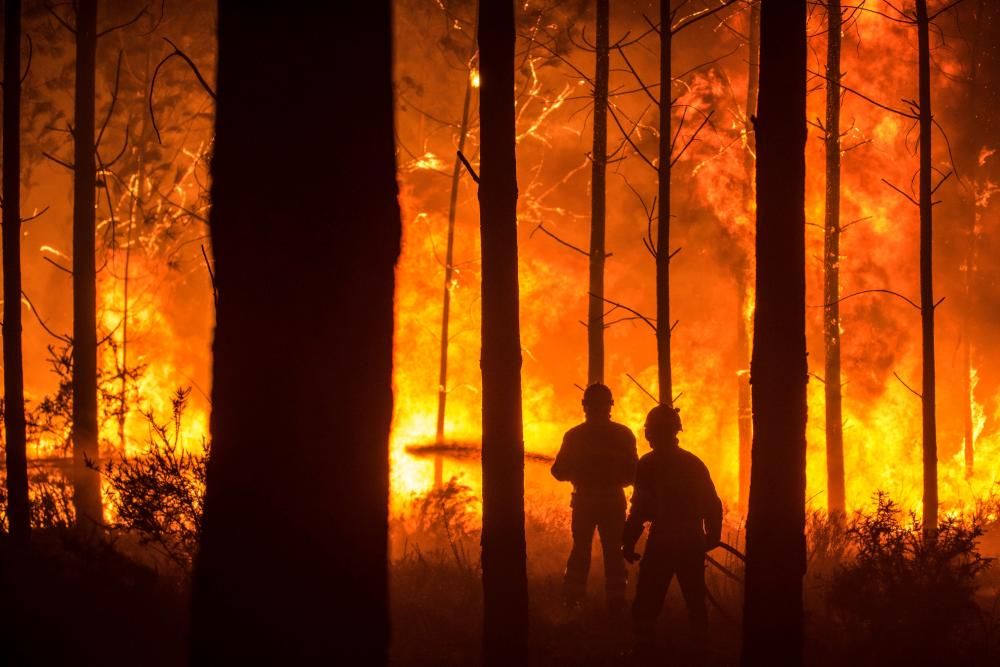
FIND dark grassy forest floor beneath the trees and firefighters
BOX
[0,489,1000,667]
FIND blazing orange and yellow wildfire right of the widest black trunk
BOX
[392,2,1000,512]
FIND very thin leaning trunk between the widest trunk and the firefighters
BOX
[434,4,479,488]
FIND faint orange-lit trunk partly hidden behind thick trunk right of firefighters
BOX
[736,2,760,514]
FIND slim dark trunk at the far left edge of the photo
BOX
[3,0,31,546]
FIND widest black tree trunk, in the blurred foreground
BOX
[191,0,400,665]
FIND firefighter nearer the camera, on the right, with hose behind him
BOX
[622,405,722,652]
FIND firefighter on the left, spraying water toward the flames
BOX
[552,383,637,611]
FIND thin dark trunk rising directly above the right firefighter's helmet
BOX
[656,0,674,405]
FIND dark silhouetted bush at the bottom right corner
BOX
[828,492,992,664]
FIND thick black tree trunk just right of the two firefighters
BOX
[742,0,808,665]
